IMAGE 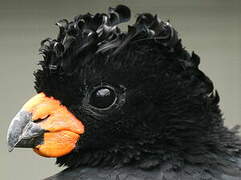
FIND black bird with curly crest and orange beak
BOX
[7,5,241,180]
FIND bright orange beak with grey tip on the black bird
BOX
[7,93,84,157]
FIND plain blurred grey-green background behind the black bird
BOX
[0,0,241,180]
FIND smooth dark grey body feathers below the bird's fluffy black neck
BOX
[45,161,241,180]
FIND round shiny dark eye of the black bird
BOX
[89,87,116,109]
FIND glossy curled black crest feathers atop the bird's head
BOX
[39,5,181,72]
